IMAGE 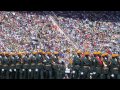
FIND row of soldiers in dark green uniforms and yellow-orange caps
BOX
[0,50,120,79]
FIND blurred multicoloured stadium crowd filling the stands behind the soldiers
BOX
[0,11,120,54]
